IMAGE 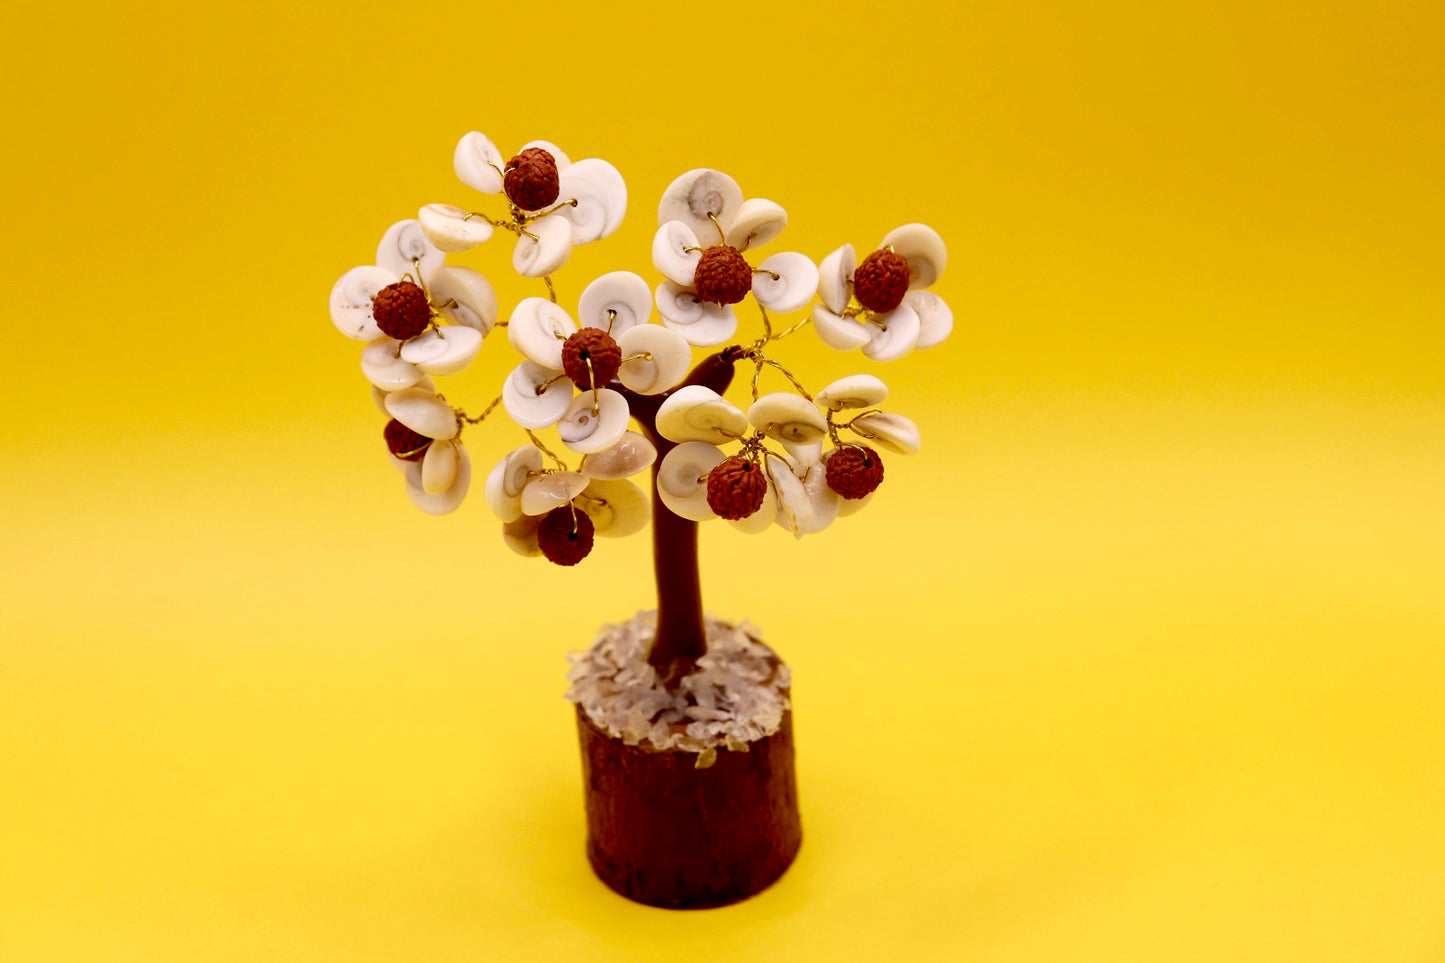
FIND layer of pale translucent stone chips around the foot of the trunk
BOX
[566,612,790,753]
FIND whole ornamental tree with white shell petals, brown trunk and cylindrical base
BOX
[331,132,952,907]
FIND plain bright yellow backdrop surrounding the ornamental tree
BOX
[0,0,1445,963]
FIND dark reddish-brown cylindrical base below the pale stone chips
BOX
[577,706,802,910]
